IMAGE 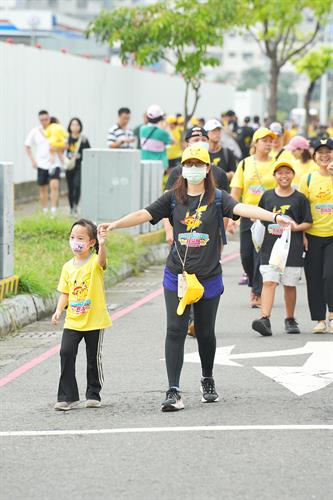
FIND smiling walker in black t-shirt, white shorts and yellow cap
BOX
[252,162,312,336]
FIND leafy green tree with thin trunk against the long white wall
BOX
[88,0,243,129]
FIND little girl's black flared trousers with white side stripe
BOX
[58,328,104,403]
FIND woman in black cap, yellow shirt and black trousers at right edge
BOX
[299,139,333,333]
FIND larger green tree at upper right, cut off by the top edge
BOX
[245,0,332,120]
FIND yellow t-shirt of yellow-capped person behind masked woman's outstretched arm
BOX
[230,156,276,205]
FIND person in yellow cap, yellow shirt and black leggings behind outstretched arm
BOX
[230,127,276,308]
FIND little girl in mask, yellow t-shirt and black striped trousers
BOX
[52,219,112,410]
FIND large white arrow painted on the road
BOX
[184,342,333,396]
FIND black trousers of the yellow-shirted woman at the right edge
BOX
[304,234,333,321]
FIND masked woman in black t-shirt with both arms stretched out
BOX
[99,147,291,411]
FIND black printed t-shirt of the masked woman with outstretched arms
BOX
[146,191,238,280]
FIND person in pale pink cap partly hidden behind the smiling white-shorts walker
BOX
[285,135,319,189]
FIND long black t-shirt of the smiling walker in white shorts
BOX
[259,189,312,267]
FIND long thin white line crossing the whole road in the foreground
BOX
[0,424,333,437]
